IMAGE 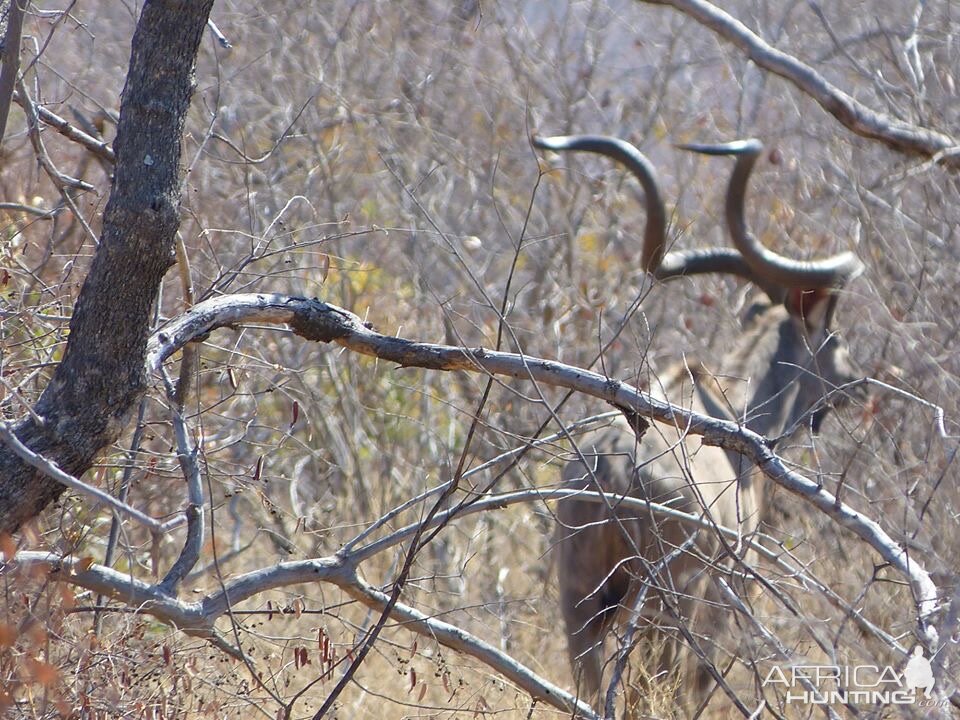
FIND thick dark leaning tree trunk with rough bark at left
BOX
[0,0,213,532]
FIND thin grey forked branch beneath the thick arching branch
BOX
[0,480,936,717]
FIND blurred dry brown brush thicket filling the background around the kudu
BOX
[0,0,960,718]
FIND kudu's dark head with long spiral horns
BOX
[533,135,863,434]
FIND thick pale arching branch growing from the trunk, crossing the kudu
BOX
[147,294,939,645]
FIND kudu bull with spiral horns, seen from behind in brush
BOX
[534,136,862,716]
